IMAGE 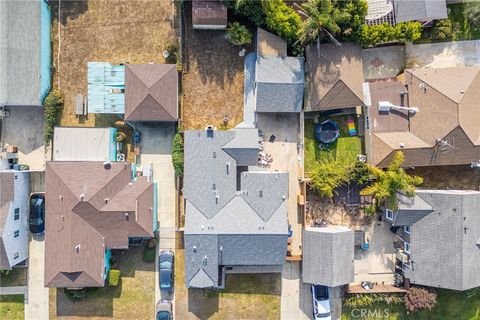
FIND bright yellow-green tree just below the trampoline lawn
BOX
[310,161,350,198]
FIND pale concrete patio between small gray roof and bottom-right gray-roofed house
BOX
[353,220,395,284]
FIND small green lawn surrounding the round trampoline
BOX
[304,116,362,173]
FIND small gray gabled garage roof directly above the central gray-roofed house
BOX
[255,56,305,112]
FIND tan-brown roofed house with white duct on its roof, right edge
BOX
[365,67,480,167]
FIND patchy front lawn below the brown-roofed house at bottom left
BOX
[50,247,155,319]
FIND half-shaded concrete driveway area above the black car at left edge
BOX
[1,107,45,170]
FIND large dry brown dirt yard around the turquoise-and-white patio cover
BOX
[52,0,175,126]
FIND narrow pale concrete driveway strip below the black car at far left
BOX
[25,235,48,320]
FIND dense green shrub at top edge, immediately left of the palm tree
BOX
[262,0,301,43]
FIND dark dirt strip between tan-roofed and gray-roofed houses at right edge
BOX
[407,165,480,190]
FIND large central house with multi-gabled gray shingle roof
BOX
[183,128,288,288]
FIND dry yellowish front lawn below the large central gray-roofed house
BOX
[175,249,280,320]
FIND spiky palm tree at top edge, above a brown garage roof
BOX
[294,0,348,46]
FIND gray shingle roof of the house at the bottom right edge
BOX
[406,190,480,290]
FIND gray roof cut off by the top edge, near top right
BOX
[394,0,447,23]
